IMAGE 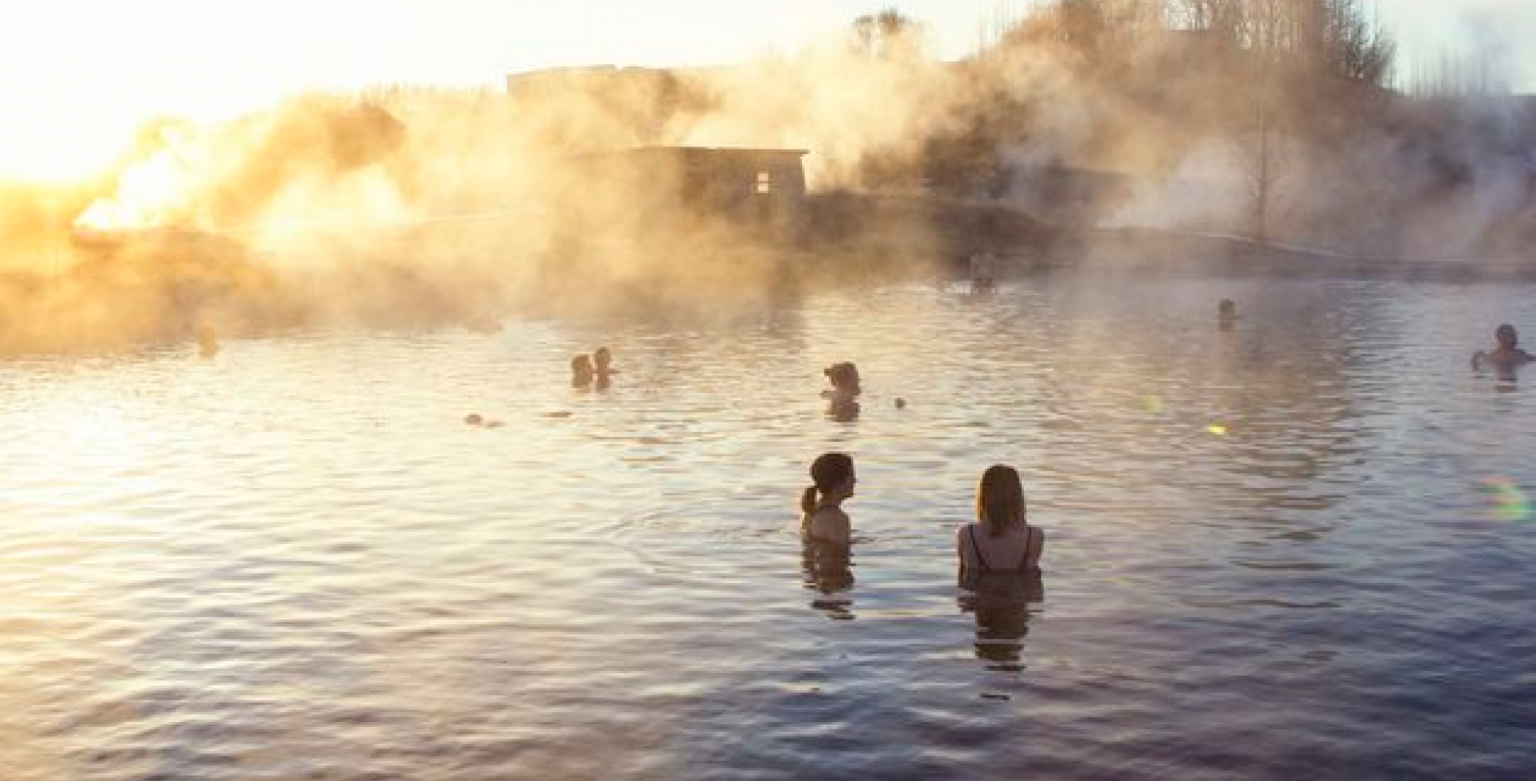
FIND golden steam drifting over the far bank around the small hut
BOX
[0,11,1536,354]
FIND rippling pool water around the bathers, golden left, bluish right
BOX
[0,278,1536,781]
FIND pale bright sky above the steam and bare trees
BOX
[0,0,1536,175]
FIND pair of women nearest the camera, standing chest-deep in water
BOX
[800,452,1046,575]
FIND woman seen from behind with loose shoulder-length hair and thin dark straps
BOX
[955,464,1046,575]
